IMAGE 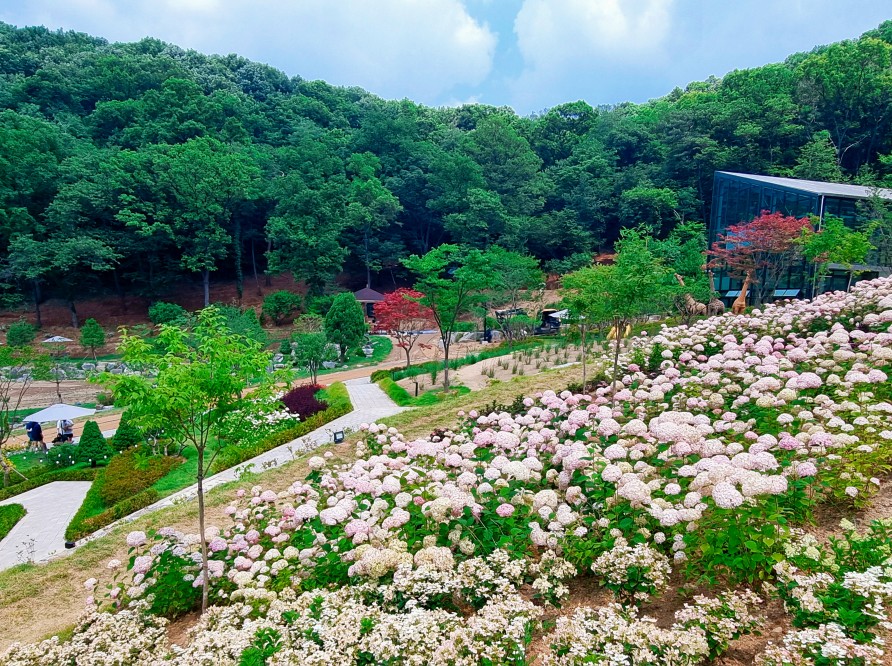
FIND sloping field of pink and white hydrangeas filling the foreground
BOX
[0,279,892,666]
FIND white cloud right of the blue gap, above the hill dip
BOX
[512,0,674,106]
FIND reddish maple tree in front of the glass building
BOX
[709,210,811,303]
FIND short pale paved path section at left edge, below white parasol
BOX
[0,481,91,570]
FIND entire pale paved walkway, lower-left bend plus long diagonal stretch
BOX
[0,377,405,570]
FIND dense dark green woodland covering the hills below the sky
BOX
[0,21,892,320]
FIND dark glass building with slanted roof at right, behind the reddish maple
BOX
[709,171,892,303]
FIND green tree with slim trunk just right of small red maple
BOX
[403,244,493,389]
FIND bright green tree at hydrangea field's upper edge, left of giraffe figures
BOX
[563,229,678,405]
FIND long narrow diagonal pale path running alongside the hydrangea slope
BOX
[76,377,406,552]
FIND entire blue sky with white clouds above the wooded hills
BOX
[0,0,892,115]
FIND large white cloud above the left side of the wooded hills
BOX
[0,0,497,103]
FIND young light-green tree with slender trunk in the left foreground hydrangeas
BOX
[99,307,278,611]
